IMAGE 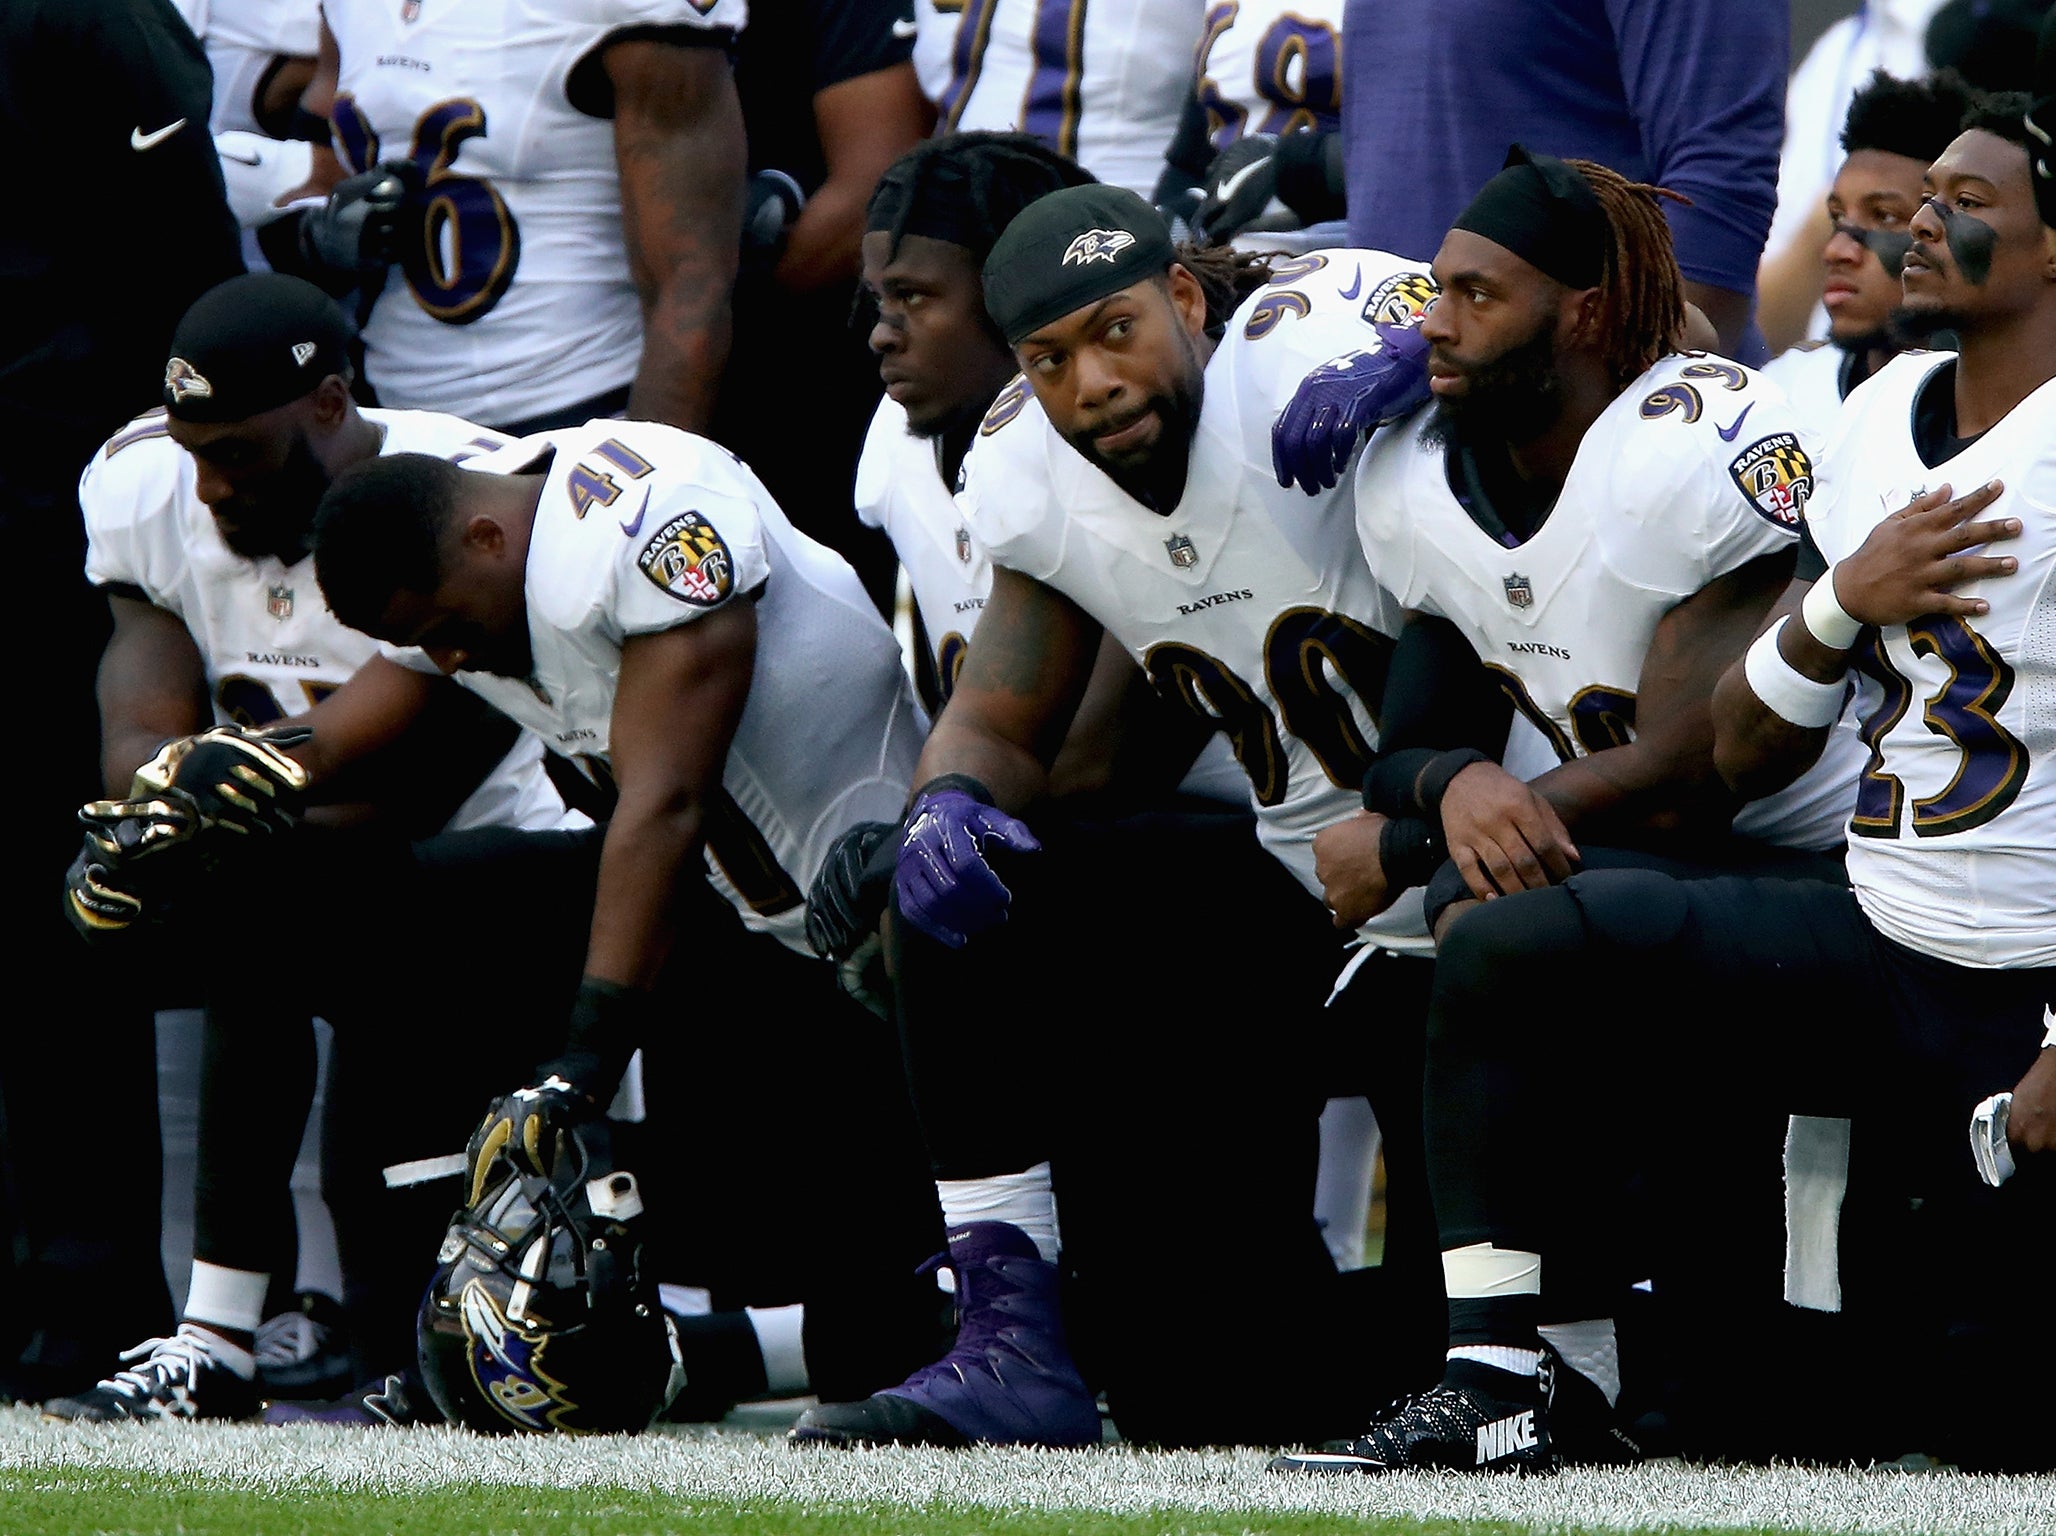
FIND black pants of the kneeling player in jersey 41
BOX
[220,829,942,1396]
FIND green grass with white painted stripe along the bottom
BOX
[0,1409,2056,1536]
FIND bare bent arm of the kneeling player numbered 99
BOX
[1534,549,1797,831]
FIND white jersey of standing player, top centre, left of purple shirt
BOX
[938,0,1207,197]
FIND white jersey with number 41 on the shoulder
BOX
[387,422,927,954]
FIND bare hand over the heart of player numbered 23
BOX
[1824,479,2021,625]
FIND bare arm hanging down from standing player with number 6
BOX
[600,37,744,432]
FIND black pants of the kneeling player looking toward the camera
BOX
[894,812,1419,1443]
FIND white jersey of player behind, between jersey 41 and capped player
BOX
[857,399,1248,804]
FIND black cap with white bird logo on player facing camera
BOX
[985,183,1172,345]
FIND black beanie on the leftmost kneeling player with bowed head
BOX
[164,271,350,422]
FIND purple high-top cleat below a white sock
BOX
[792,1221,1100,1446]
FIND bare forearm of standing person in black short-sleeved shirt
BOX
[777,62,935,292]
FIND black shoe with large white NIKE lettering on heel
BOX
[1271,1361,1556,1472]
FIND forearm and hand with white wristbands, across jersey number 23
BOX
[1713,481,2021,796]
